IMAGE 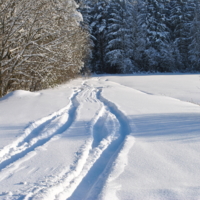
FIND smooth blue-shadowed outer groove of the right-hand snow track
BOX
[68,90,131,200]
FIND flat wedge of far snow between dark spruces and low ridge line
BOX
[106,73,200,104]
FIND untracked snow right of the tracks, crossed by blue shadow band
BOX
[95,77,200,200]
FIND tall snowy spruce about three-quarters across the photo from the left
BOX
[144,0,174,71]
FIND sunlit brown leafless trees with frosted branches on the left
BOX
[0,0,89,97]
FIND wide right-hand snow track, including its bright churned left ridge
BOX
[24,84,130,200]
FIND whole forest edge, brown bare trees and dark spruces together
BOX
[0,0,200,97]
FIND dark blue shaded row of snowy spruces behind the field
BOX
[78,0,200,73]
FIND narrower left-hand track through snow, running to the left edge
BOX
[0,88,80,177]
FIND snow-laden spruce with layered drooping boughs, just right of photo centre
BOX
[106,0,132,73]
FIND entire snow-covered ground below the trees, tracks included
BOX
[0,74,200,200]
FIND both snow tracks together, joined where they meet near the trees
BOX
[0,81,134,200]
